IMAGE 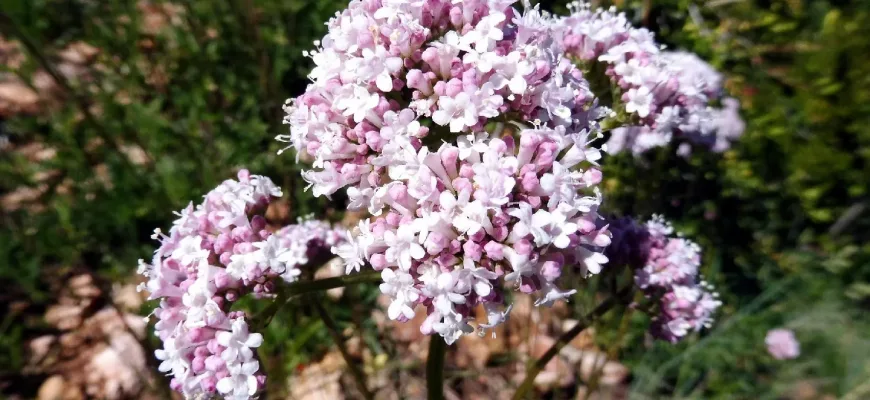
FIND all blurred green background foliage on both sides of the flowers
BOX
[0,0,870,398]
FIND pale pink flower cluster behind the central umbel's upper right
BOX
[561,3,742,154]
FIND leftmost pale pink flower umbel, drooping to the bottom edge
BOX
[139,170,345,399]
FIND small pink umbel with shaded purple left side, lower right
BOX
[606,216,722,343]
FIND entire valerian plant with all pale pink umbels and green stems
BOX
[142,0,739,399]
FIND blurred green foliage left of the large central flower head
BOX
[0,0,342,390]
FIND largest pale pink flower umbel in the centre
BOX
[286,0,610,343]
